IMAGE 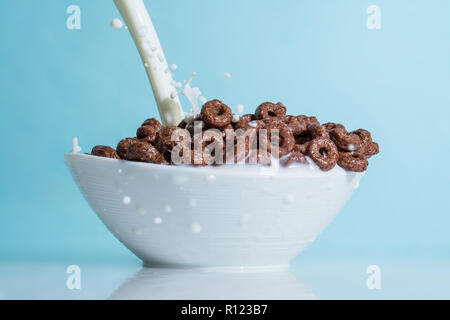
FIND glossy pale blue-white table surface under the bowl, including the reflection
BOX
[0,258,450,299]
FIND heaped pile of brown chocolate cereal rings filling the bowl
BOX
[91,100,379,172]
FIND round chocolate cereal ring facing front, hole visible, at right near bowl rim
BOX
[307,138,339,171]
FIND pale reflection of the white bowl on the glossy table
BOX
[110,268,317,300]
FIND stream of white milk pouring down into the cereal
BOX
[114,0,184,126]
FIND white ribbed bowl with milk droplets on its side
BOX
[65,154,363,267]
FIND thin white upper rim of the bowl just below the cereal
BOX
[64,153,365,178]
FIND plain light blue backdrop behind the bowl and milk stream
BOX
[0,0,450,264]
